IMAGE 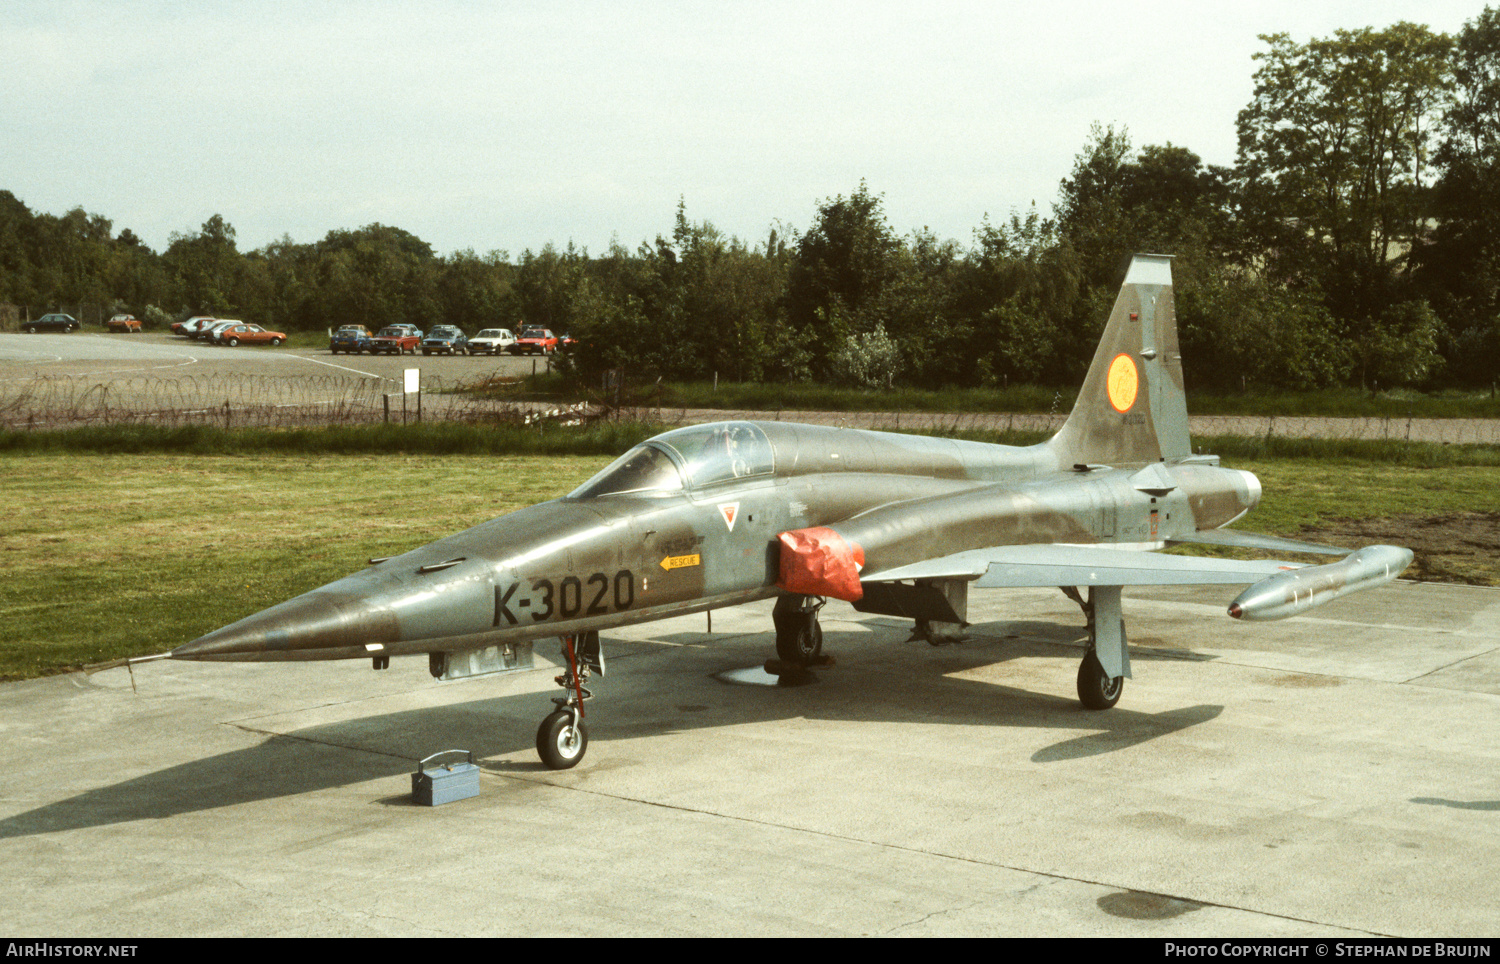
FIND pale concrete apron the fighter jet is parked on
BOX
[0,583,1500,937]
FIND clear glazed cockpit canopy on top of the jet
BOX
[569,421,776,499]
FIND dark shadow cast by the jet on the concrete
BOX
[0,622,1223,838]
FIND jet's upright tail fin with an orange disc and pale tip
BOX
[1049,255,1193,465]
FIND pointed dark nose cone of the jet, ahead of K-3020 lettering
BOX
[173,591,398,660]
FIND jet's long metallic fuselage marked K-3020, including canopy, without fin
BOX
[173,421,1260,660]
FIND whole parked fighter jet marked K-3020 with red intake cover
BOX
[135,255,1412,768]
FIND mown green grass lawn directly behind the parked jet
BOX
[0,453,1500,679]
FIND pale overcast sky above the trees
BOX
[0,0,1484,256]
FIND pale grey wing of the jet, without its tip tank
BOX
[861,544,1304,589]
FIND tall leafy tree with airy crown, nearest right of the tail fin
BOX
[1236,22,1452,313]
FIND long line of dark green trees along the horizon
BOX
[0,7,1500,391]
